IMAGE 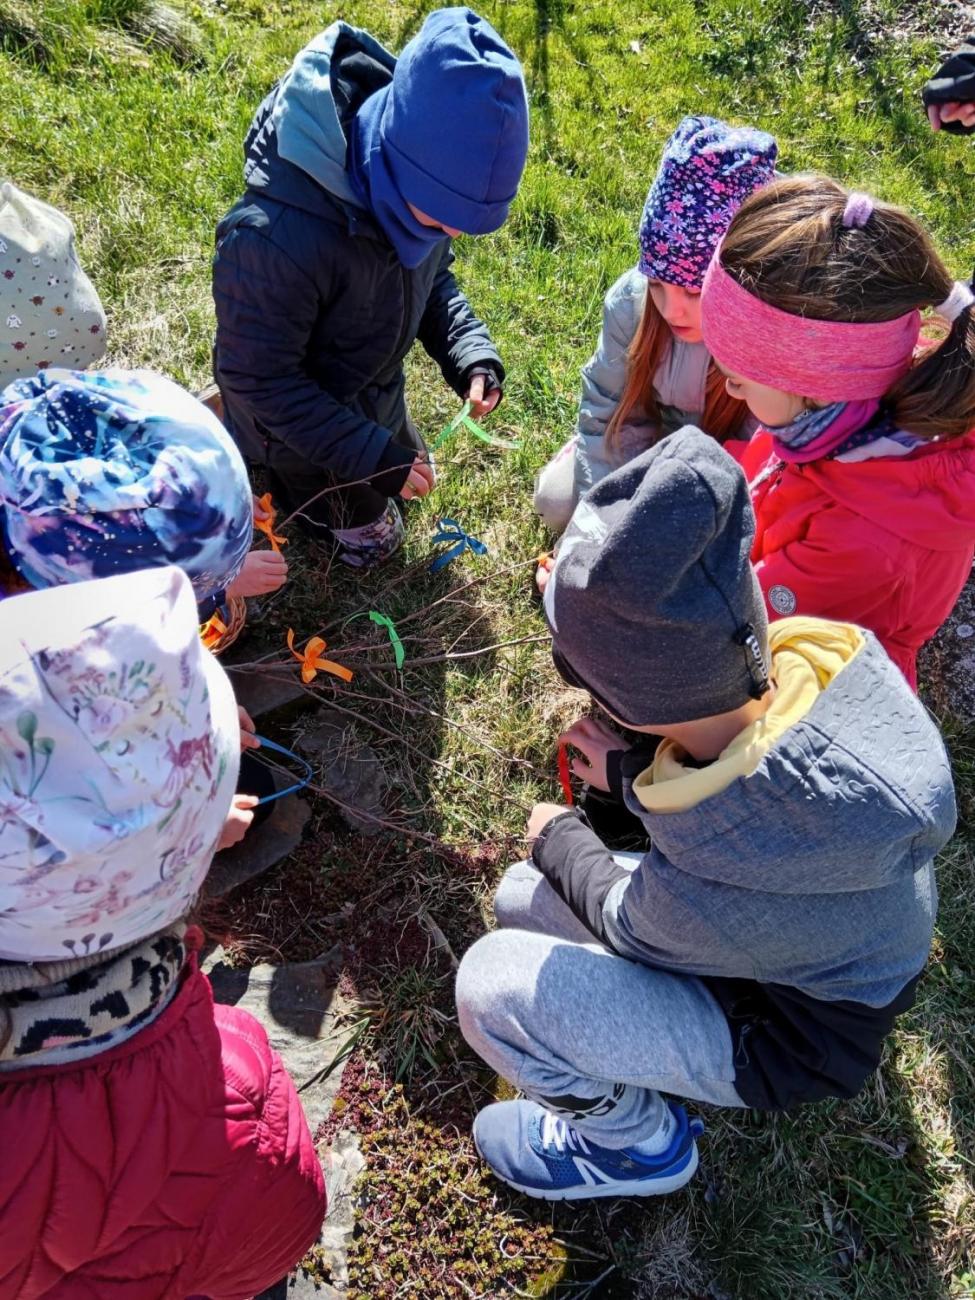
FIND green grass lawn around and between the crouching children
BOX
[0,0,975,1300]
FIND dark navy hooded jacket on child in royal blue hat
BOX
[213,22,504,495]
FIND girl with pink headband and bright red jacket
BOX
[702,176,975,685]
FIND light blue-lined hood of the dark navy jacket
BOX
[244,22,397,212]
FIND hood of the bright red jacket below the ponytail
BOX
[802,432,975,551]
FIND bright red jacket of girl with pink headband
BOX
[725,430,975,688]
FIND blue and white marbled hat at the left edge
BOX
[0,369,254,599]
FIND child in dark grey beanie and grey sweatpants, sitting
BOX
[456,428,956,1200]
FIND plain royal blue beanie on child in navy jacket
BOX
[378,8,528,235]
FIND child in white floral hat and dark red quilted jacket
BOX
[0,567,325,1300]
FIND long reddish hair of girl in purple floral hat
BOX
[606,290,749,447]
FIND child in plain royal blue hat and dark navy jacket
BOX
[213,8,528,567]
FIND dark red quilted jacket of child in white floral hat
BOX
[0,959,325,1300]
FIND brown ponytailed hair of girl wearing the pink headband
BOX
[720,176,975,438]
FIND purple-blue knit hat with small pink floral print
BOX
[637,117,779,289]
